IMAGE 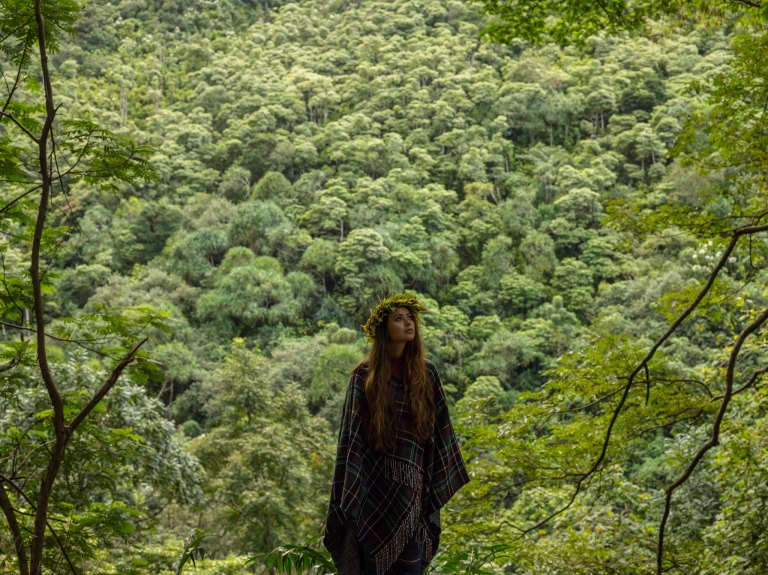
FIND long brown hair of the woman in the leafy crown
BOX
[355,314,435,451]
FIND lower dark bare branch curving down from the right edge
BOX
[656,309,768,575]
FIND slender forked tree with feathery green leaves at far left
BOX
[0,0,160,575]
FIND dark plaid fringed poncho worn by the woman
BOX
[324,362,469,574]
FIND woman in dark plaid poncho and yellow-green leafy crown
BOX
[324,294,469,575]
